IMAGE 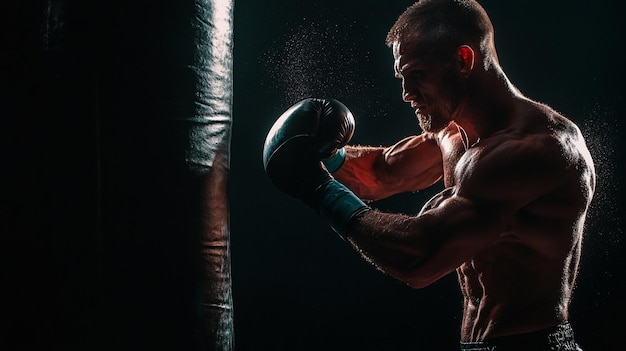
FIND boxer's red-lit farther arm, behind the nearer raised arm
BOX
[333,133,443,200]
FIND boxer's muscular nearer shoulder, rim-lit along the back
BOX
[455,99,593,217]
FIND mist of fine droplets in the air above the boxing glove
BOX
[262,19,378,113]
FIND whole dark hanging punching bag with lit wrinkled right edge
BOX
[96,0,233,350]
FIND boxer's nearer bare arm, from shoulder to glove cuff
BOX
[336,139,567,288]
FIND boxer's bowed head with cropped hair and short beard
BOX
[386,0,497,132]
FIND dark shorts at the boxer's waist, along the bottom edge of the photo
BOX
[461,323,582,351]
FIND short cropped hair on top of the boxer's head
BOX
[386,0,495,56]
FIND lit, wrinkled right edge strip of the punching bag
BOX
[187,0,234,351]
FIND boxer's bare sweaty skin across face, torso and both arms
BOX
[333,36,595,342]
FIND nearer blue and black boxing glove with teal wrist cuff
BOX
[263,98,370,239]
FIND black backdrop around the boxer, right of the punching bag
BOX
[230,0,626,350]
